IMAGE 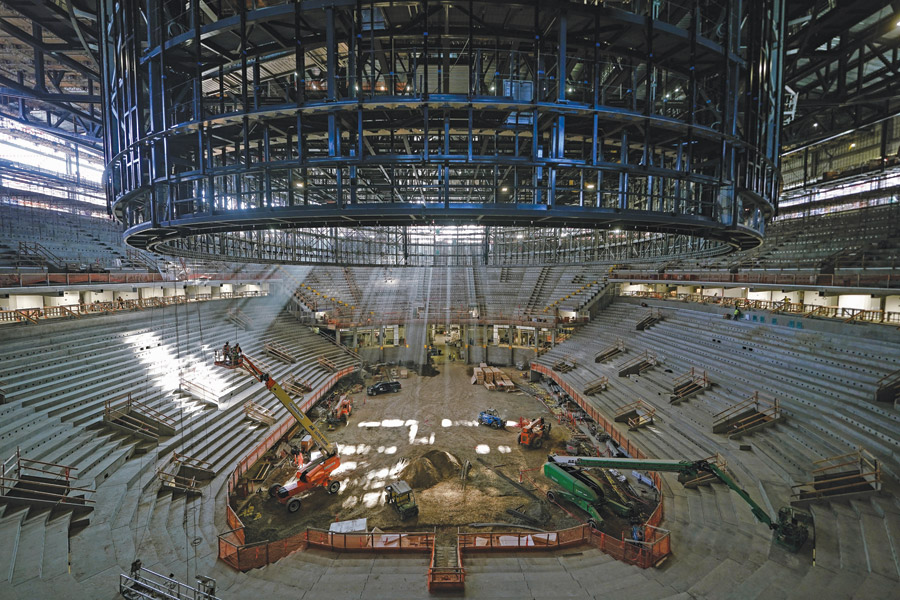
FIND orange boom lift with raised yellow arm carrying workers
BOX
[215,354,341,513]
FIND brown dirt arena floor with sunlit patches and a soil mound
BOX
[237,362,652,543]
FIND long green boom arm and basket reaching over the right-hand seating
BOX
[544,456,812,552]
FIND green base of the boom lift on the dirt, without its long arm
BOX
[544,456,638,529]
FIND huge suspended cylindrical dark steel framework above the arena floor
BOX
[100,0,784,265]
